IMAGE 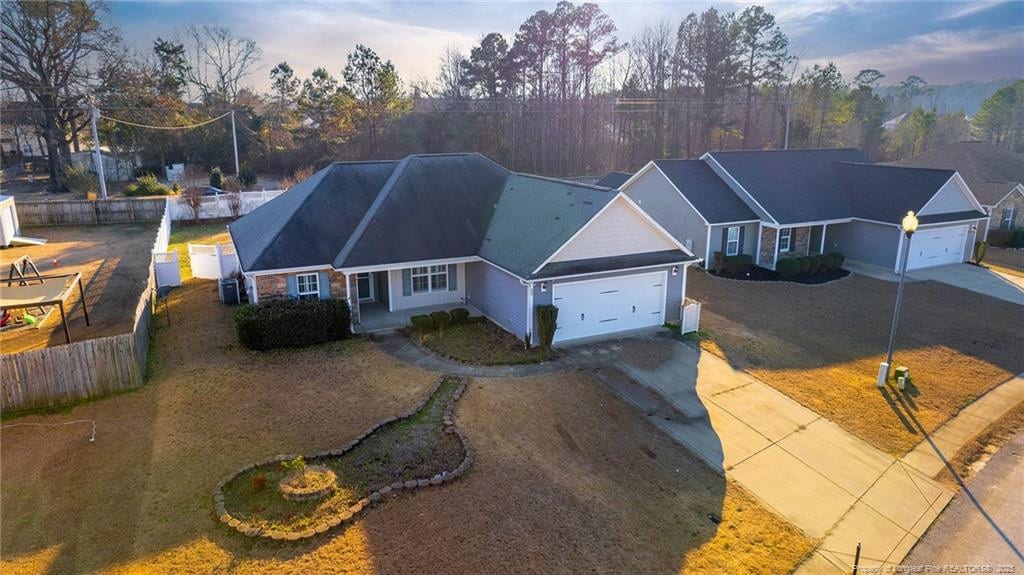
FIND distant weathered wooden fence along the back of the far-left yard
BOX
[14,197,167,226]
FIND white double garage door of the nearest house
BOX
[552,271,668,342]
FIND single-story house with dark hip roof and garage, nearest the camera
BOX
[228,153,699,342]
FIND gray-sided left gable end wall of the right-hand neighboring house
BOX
[623,167,708,258]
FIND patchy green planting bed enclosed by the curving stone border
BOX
[223,377,465,531]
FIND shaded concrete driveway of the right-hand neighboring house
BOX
[843,261,1024,305]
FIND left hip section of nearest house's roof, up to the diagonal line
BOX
[227,162,396,271]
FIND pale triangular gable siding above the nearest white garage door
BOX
[551,194,678,262]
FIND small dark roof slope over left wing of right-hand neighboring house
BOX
[654,160,760,224]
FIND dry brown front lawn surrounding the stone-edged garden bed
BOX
[0,281,811,574]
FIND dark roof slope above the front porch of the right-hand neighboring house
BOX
[708,149,868,224]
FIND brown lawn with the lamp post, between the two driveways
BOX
[689,273,1024,455]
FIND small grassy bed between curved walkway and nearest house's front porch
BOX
[410,318,555,365]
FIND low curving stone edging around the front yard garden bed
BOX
[213,374,476,541]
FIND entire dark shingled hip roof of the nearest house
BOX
[235,153,643,277]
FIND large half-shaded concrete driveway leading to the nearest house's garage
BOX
[567,331,952,573]
